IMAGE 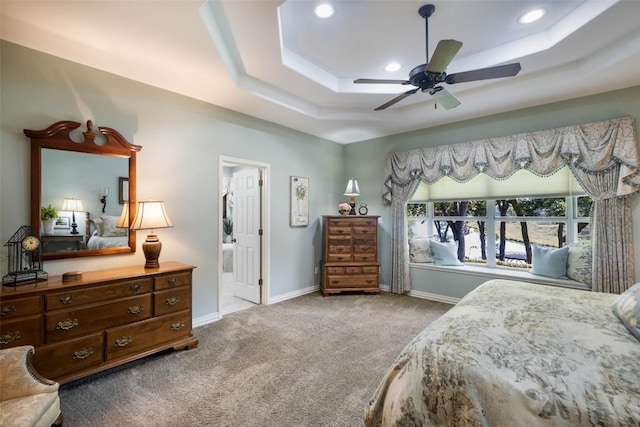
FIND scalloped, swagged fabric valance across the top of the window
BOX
[382,117,640,204]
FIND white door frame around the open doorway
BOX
[217,156,271,318]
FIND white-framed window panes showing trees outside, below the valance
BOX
[407,196,592,268]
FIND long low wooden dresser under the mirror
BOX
[0,262,198,383]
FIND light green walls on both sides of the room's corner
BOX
[0,41,640,310]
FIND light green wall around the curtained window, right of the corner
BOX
[345,86,640,298]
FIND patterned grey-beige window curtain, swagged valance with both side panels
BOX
[382,113,640,293]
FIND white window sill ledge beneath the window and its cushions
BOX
[409,263,591,291]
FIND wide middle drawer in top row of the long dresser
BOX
[46,278,152,310]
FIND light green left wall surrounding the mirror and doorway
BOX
[0,41,346,318]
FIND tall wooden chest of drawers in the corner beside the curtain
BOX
[320,215,380,296]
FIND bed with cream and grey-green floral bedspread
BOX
[365,280,640,427]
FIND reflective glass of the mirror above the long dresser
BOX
[41,149,129,253]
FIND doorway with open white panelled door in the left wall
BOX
[217,156,270,317]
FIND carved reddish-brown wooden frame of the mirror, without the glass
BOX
[24,120,142,260]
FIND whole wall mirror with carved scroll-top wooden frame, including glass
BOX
[24,120,142,260]
